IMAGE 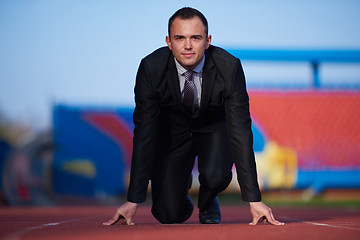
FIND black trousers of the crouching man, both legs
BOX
[151,133,233,223]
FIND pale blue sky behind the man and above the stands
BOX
[0,0,360,129]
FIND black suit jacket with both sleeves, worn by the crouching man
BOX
[128,46,261,203]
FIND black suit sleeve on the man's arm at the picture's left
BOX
[127,60,160,203]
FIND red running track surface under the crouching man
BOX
[0,206,360,240]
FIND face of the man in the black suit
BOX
[166,17,211,70]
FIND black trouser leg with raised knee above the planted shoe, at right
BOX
[195,133,233,209]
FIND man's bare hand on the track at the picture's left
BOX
[103,202,138,226]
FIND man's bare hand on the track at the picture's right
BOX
[249,202,284,225]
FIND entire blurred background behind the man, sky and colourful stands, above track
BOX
[0,0,360,206]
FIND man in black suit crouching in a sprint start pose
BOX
[104,8,283,225]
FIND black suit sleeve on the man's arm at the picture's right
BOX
[224,60,261,202]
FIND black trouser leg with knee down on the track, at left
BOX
[151,136,195,223]
